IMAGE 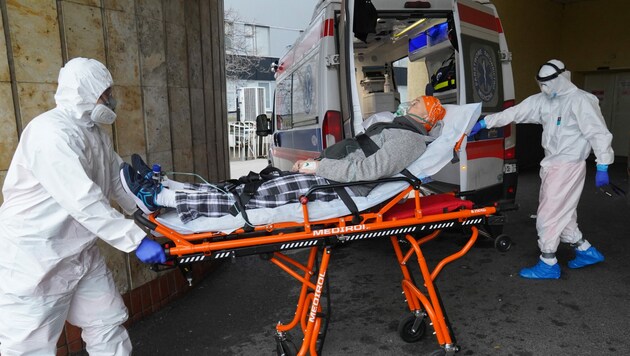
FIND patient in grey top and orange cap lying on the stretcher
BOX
[120,96,445,223]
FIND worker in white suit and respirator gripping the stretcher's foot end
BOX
[0,58,164,356]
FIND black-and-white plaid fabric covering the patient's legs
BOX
[175,174,338,223]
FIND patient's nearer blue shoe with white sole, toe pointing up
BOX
[120,162,162,214]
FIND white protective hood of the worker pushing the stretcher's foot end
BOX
[55,58,114,122]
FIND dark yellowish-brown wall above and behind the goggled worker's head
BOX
[492,0,630,102]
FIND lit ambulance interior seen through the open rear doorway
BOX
[353,12,457,120]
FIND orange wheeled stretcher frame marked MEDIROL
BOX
[134,178,513,355]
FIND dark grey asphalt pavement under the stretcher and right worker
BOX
[129,158,630,356]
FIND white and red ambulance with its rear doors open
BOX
[257,0,517,211]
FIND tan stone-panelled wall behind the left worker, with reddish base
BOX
[0,0,229,293]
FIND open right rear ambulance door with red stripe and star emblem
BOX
[453,0,513,202]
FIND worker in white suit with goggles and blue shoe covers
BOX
[471,59,614,279]
